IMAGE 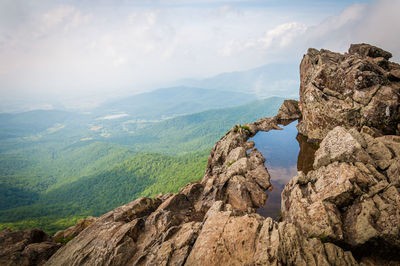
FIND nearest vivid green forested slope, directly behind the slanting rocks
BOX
[0,152,208,233]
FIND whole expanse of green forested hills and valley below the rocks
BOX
[0,98,283,233]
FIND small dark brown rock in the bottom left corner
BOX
[0,229,61,266]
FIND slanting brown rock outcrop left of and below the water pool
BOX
[43,98,357,265]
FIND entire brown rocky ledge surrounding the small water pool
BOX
[0,44,400,265]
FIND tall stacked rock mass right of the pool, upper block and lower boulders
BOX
[282,44,400,264]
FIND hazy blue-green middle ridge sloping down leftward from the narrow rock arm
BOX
[109,97,284,155]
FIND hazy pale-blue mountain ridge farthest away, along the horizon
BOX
[0,63,299,113]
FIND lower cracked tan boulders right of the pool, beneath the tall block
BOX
[282,127,400,260]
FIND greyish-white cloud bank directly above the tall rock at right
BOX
[295,0,400,62]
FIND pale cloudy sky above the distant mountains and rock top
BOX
[0,0,400,110]
